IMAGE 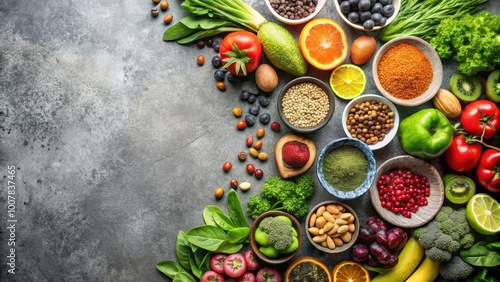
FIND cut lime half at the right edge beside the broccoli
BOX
[465,193,500,235]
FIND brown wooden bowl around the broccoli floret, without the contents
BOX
[250,211,302,265]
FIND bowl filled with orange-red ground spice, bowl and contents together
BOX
[372,36,443,107]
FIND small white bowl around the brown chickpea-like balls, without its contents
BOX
[342,94,399,150]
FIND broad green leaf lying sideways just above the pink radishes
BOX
[185,225,227,252]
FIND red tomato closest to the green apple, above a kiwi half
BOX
[444,135,482,172]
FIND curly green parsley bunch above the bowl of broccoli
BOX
[247,173,314,219]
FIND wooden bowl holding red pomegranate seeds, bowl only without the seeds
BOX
[370,155,444,228]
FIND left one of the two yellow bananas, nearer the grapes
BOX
[371,236,424,282]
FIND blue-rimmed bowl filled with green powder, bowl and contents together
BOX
[316,137,377,200]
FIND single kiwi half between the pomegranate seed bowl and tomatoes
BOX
[443,174,476,204]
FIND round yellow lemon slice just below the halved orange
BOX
[330,64,366,100]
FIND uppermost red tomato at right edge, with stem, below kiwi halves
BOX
[460,100,500,139]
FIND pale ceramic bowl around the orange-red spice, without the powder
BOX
[372,36,443,107]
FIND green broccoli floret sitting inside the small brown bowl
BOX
[259,217,293,251]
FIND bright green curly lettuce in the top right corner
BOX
[430,11,500,75]
